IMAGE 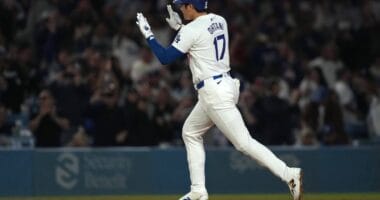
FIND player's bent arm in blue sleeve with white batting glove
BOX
[136,13,185,65]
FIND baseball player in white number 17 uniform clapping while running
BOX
[136,0,302,200]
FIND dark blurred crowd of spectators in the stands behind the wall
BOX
[0,0,380,147]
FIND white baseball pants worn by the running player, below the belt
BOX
[182,73,289,193]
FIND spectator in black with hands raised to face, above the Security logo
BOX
[29,90,70,147]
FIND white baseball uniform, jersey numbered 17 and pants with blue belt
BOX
[172,13,290,193]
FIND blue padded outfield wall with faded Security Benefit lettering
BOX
[0,146,380,196]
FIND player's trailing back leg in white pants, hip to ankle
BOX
[199,76,287,181]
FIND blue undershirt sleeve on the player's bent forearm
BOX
[147,38,185,65]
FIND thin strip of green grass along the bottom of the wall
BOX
[0,193,380,200]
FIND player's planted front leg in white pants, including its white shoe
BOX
[182,102,214,199]
